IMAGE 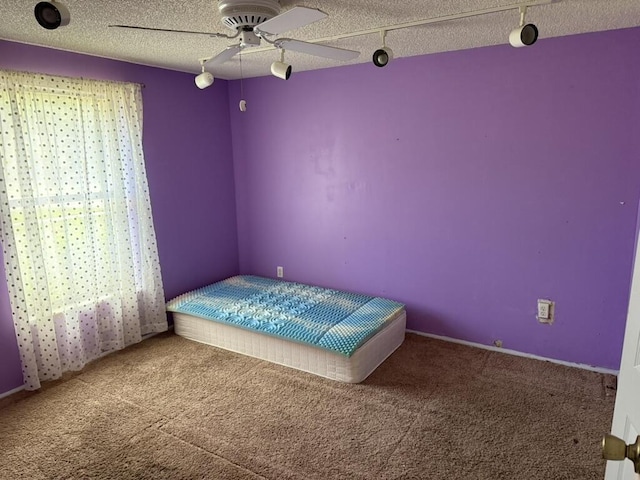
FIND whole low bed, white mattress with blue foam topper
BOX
[167,275,406,383]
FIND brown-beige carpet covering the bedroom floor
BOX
[0,334,615,480]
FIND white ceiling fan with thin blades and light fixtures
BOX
[110,0,360,82]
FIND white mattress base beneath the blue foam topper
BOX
[173,309,407,383]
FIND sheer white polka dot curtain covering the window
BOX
[0,70,167,389]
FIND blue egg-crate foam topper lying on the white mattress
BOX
[167,275,404,357]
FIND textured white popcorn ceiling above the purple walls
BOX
[0,0,640,79]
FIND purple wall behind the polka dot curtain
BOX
[0,41,238,393]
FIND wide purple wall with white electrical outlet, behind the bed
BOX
[229,28,640,369]
